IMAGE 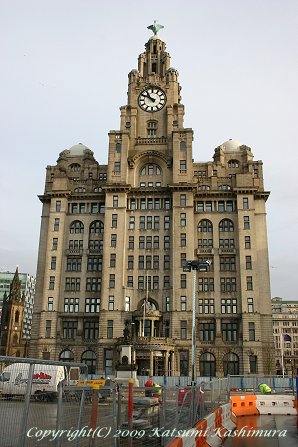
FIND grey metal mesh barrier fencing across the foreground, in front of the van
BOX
[0,357,291,447]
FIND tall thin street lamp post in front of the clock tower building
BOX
[183,259,211,386]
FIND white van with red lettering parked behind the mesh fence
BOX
[0,363,80,401]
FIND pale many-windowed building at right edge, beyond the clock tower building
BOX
[271,297,298,375]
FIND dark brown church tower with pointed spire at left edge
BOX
[0,269,28,357]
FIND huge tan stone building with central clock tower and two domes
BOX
[30,27,273,376]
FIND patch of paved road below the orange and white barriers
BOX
[224,415,298,447]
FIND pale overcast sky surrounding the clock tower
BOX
[0,0,298,299]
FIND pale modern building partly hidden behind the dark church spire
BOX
[0,272,35,340]
